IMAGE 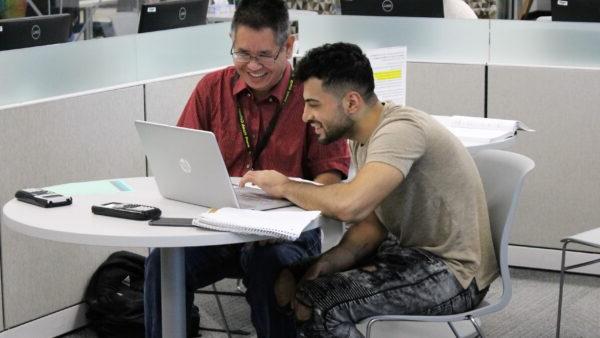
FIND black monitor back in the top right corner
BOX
[551,0,600,22]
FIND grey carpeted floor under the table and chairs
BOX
[63,269,600,338]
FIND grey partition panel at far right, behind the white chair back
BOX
[488,65,600,248]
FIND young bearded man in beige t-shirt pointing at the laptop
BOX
[242,43,498,337]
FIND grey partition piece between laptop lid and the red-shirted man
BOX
[145,74,204,125]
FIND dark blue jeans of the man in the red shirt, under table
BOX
[144,229,321,338]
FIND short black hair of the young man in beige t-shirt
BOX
[295,42,376,103]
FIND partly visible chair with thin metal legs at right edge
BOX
[556,228,600,338]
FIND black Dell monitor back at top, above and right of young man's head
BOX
[340,0,444,18]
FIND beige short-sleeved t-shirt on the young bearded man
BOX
[351,102,498,289]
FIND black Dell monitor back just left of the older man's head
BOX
[138,0,208,33]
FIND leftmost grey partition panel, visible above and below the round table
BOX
[0,86,145,328]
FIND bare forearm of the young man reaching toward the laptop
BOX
[240,162,404,223]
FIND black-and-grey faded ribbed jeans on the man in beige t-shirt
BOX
[297,237,487,338]
